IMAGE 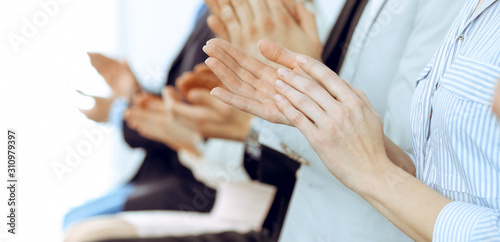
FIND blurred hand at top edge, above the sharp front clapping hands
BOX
[205,0,323,61]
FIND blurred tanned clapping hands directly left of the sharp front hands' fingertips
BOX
[172,64,253,141]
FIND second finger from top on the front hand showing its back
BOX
[277,68,338,113]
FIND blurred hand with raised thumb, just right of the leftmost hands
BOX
[124,90,201,154]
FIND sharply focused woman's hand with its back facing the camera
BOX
[275,53,392,191]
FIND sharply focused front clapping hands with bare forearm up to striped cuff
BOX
[204,39,451,241]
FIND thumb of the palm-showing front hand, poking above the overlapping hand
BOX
[258,40,298,69]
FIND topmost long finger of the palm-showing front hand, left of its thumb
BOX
[204,39,275,78]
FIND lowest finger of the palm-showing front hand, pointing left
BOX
[210,87,286,122]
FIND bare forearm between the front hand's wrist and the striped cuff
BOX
[358,163,451,241]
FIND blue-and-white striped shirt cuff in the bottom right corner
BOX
[433,201,500,242]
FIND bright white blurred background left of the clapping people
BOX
[0,0,202,241]
